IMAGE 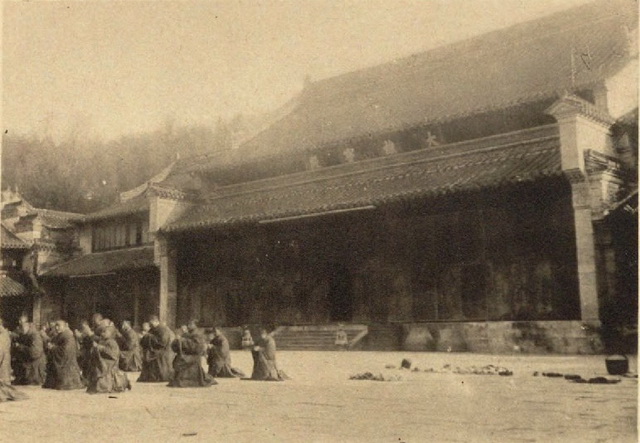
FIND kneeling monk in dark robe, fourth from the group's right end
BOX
[138,316,175,382]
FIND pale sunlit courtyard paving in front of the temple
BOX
[0,351,638,443]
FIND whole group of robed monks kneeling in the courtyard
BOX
[0,314,287,401]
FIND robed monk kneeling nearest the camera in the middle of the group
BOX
[87,326,131,394]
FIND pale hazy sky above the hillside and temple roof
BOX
[1,0,589,140]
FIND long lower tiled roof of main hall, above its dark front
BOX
[163,125,561,231]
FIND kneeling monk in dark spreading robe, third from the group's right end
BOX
[169,320,217,388]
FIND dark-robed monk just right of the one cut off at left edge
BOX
[13,319,47,386]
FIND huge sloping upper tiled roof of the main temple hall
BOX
[228,0,638,161]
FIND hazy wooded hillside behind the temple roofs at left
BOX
[2,115,263,213]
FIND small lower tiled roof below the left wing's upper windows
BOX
[42,246,154,277]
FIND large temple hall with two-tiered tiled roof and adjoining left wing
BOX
[32,1,638,353]
